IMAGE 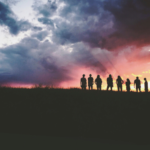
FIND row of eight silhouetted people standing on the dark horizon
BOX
[80,74,148,92]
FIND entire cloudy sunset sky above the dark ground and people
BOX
[0,0,150,90]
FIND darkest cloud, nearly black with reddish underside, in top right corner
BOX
[103,0,150,49]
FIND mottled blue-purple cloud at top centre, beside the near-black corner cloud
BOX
[50,0,115,47]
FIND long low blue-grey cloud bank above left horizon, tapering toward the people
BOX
[0,31,110,86]
